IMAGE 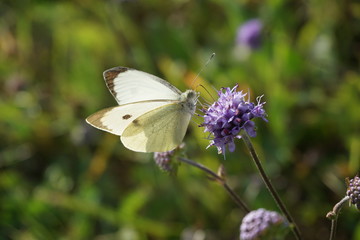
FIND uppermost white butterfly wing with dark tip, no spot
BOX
[103,67,181,105]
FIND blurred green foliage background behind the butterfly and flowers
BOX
[0,0,360,240]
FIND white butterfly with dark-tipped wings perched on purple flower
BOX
[86,67,198,152]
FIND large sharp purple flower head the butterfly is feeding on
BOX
[200,85,267,154]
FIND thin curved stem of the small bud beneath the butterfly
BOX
[178,157,250,213]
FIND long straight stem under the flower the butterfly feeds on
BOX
[240,131,301,240]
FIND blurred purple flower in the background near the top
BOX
[236,19,263,49]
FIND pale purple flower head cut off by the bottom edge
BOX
[240,208,288,240]
